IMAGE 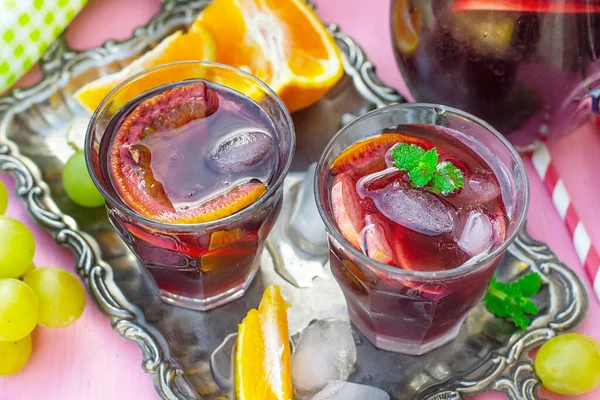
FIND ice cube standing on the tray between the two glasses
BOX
[289,163,328,255]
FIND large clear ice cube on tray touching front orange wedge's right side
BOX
[292,319,356,399]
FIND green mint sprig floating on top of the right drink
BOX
[392,143,465,196]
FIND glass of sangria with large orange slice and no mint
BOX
[85,62,295,310]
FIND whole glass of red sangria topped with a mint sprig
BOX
[315,104,529,355]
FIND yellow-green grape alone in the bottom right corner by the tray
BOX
[535,333,600,396]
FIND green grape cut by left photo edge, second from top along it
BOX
[0,216,35,278]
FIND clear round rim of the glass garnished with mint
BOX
[314,103,530,281]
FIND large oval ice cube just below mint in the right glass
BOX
[370,182,456,236]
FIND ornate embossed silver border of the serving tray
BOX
[0,1,588,400]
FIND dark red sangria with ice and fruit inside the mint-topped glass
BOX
[330,125,508,353]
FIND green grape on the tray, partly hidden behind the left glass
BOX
[63,151,104,207]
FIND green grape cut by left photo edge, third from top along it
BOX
[0,278,40,341]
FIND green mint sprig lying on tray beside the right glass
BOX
[483,272,541,329]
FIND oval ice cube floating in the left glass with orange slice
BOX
[206,130,273,174]
